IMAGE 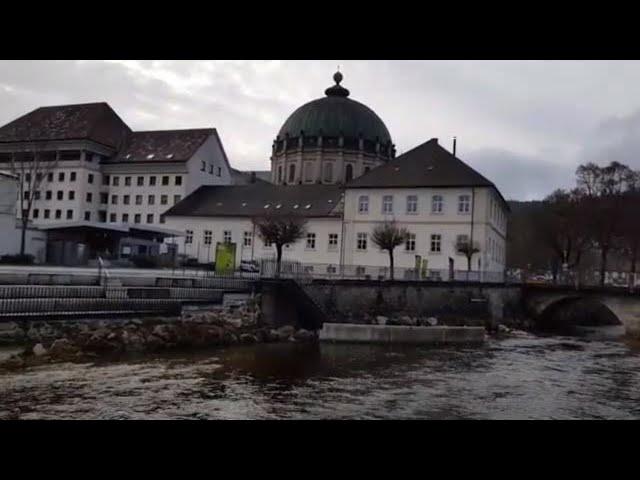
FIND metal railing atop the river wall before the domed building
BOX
[260,259,505,283]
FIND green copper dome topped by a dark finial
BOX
[278,72,391,144]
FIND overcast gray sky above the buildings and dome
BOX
[0,60,640,200]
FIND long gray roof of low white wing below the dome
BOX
[165,182,342,217]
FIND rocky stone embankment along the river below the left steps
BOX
[0,298,317,370]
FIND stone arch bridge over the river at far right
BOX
[521,285,640,338]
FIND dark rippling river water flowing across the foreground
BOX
[0,327,640,419]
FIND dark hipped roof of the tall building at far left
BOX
[0,102,131,150]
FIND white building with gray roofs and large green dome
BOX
[165,74,509,275]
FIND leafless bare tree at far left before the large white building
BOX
[11,147,58,255]
